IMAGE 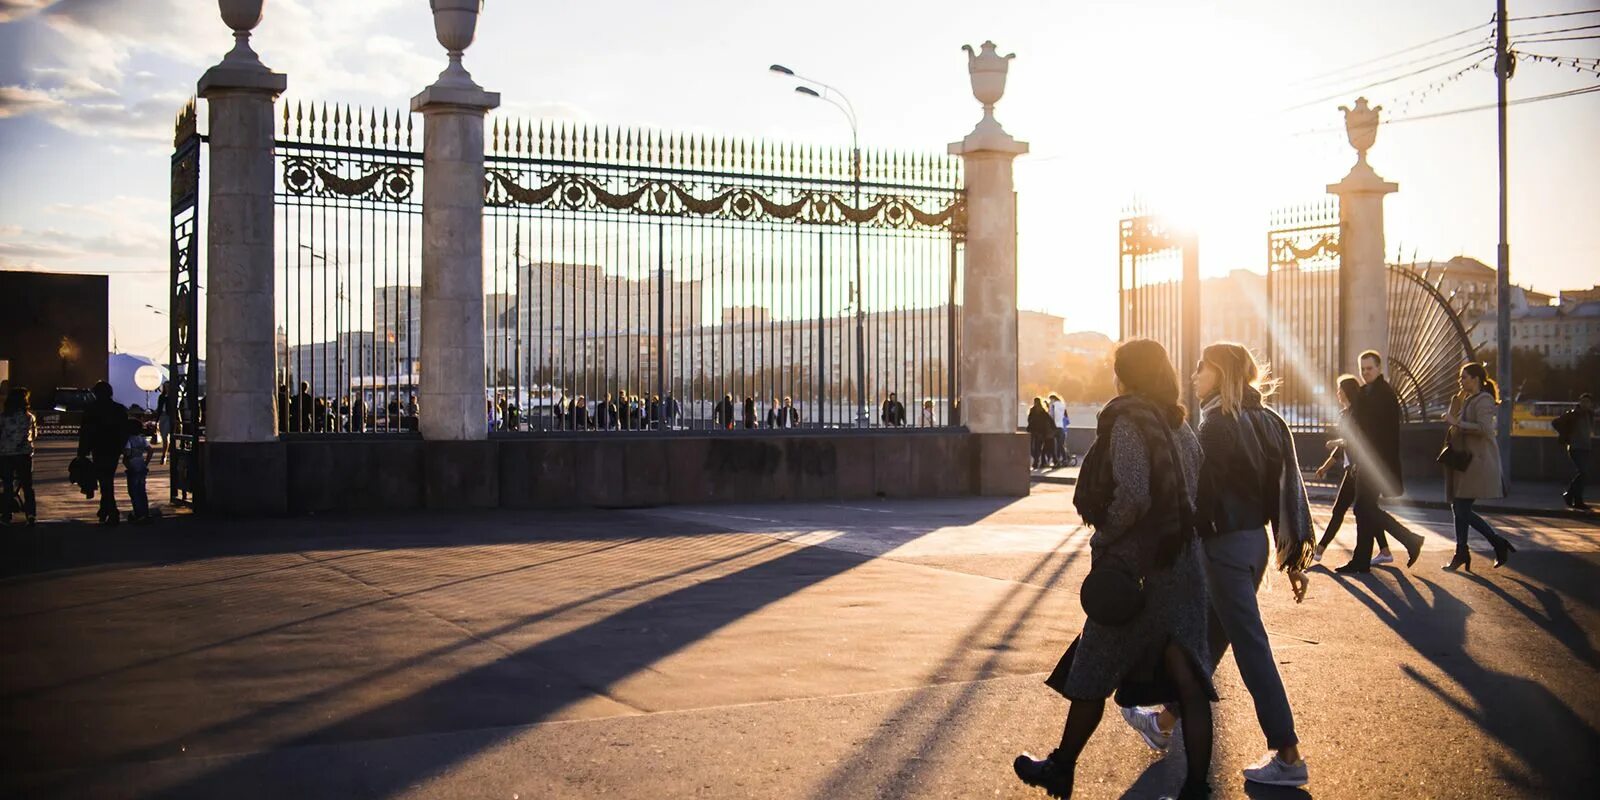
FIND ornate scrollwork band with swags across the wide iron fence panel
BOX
[483,168,960,229]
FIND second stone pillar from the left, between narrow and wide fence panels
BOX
[411,0,499,442]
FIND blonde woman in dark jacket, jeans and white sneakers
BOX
[1123,342,1312,786]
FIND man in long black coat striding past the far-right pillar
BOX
[1334,350,1422,574]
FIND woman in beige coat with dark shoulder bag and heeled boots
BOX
[1445,362,1517,573]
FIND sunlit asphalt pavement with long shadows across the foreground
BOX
[0,451,1600,798]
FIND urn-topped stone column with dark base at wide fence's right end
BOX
[950,42,1027,494]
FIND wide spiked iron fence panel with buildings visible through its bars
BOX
[485,120,963,430]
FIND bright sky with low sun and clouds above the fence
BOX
[0,0,1600,358]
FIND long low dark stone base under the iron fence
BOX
[200,430,1029,515]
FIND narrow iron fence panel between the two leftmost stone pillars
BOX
[274,101,422,434]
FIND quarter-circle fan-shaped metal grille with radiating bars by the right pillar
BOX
[1389,264,1477,422]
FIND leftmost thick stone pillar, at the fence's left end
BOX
[198,0,286,443]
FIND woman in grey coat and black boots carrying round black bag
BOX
[1013,339,1216,800]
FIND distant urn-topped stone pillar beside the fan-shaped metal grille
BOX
[1328,98,1400,373]
